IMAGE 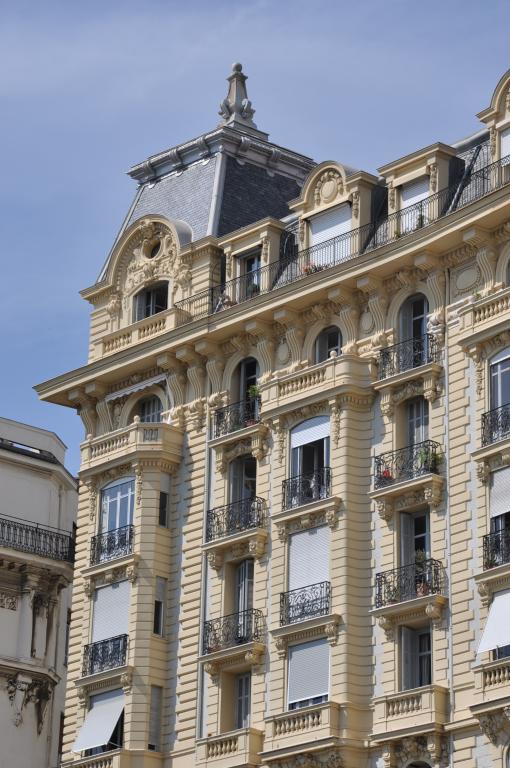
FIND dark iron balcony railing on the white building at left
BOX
[0,516,74,563]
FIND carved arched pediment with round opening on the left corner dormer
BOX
[82,216,192,311]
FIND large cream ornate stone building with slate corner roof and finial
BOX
[37,65,510,768]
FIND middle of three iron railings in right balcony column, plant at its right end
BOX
[374,440,443,490]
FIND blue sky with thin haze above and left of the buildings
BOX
[0,0,510,472]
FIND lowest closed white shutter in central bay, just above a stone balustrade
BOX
[288,639,329,704]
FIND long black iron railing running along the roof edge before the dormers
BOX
[175,157,510,325]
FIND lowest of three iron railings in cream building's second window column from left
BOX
[202,608,264,654]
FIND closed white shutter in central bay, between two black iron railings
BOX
[289,525,331,590]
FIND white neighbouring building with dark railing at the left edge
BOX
[0,418,77,768]
